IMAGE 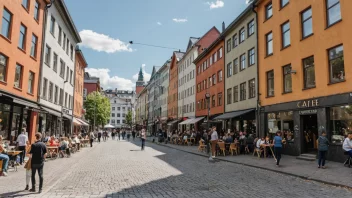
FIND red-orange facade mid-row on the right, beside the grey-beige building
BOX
[194,37,225,127]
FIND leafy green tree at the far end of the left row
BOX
[84,91,111,129]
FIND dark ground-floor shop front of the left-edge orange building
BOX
[0,93,39,144]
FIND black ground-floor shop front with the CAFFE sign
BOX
[259,93,352,162]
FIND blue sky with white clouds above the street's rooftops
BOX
[65,0,247,90]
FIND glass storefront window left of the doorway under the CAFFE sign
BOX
[266,111,294,142]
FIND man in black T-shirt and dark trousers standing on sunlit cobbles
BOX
[29,133,47,193]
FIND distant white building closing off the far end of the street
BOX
[105,90,135,128]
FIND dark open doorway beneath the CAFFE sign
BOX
[301,114,318,154]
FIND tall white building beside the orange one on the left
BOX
[38,0,81,134]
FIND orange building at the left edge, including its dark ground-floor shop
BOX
[0,0,50,142]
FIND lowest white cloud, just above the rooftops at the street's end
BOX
[86,68,135,90]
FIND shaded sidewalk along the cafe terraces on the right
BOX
[147,137,352,188]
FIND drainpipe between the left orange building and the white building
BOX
[37,0,55,133]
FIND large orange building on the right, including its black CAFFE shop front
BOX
[257,0,352,161]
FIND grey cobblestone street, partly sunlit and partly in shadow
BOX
[0,140,352,198]
